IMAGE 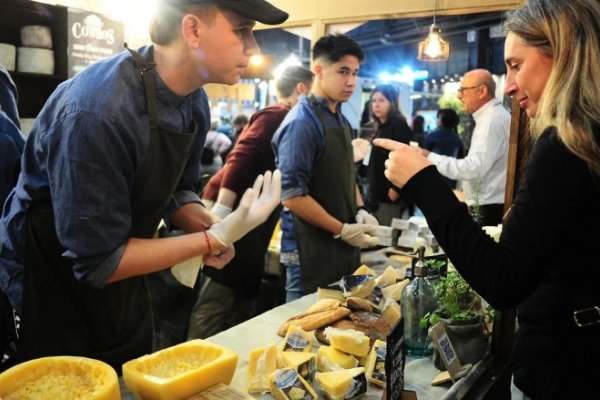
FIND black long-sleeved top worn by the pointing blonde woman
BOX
[404,129,600,399]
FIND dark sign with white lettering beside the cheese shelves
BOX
[67,8,124,78]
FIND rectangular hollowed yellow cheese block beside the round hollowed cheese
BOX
[123,339,238,400]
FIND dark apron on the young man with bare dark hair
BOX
[292,96,360,293]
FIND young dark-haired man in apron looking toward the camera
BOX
[273,34,377,301]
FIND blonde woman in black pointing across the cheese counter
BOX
[377,0,600,399]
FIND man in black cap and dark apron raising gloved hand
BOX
[0,0,287,371]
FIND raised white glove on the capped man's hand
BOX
[207,170,281,246]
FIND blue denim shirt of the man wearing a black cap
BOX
[0,47,210,312]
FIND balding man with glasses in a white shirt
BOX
[422,69,510,226]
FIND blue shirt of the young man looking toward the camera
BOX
[271,97,350,253]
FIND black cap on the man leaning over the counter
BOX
[162,0,289,25]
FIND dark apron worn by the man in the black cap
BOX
[18,46,196,373]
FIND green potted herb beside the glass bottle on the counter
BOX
[421,260,493,370]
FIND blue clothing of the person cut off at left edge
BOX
[0,64,25,210]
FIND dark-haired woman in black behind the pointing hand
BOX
[365,84,413,226]
